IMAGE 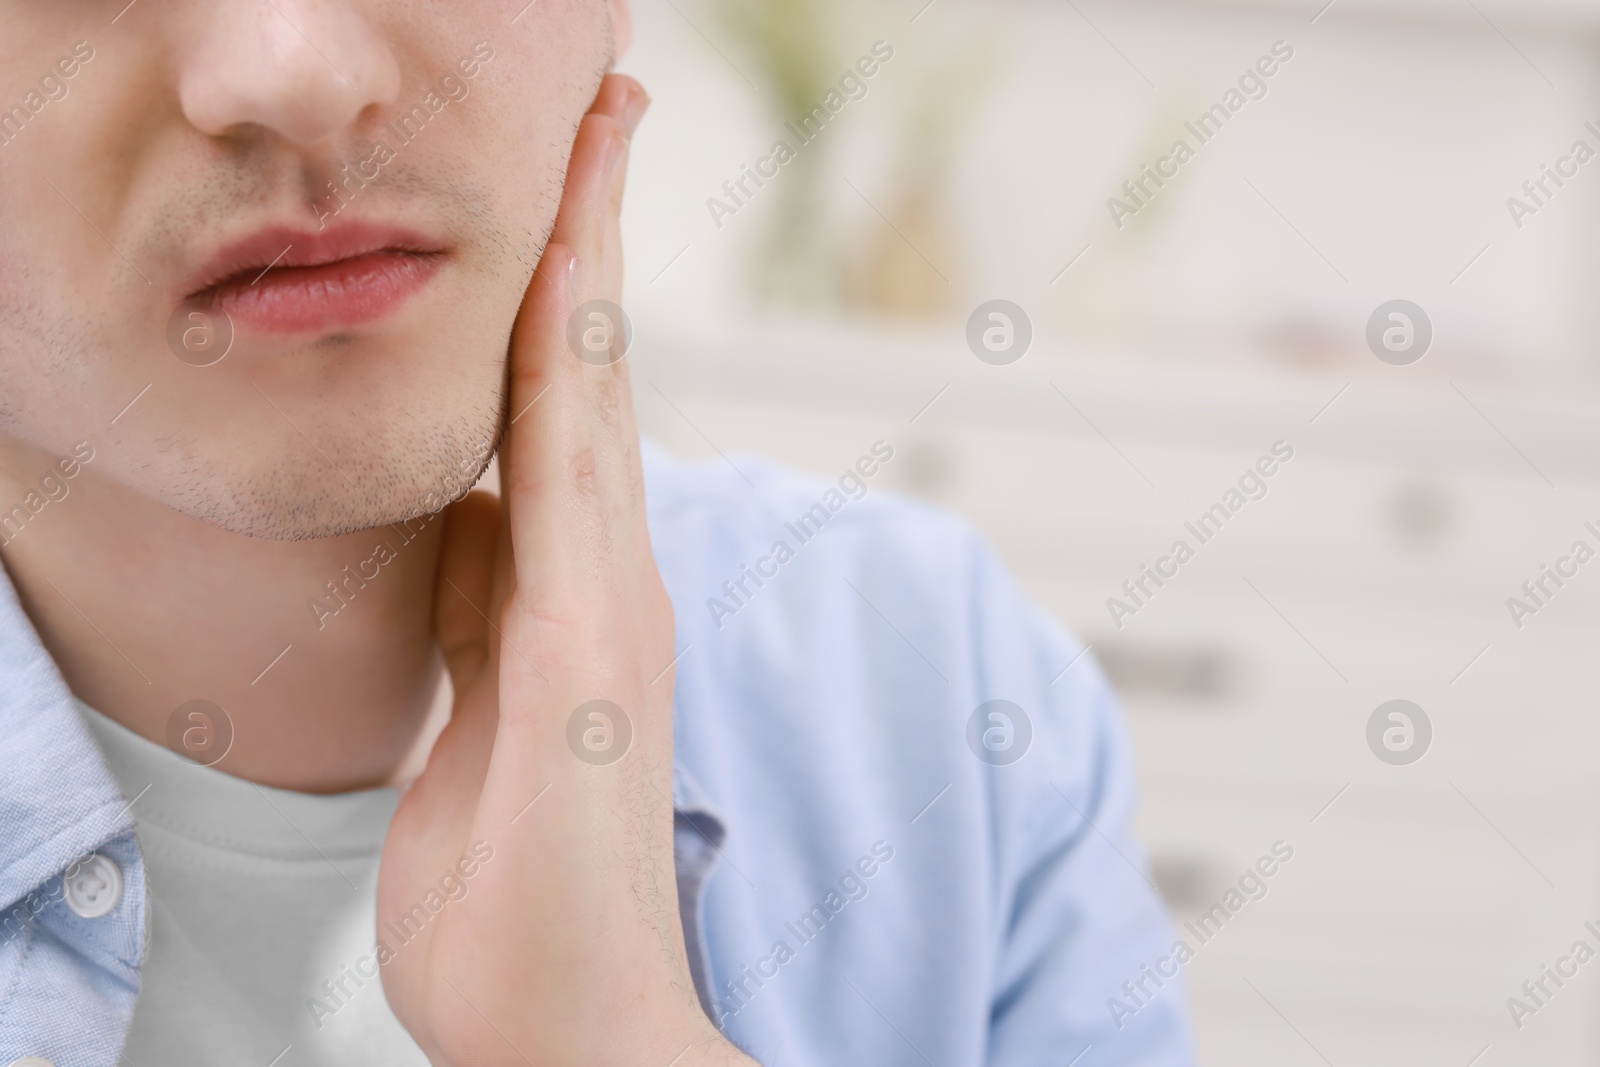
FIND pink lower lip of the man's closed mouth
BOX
[210,251,440,333]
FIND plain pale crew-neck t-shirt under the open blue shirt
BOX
[78,702,427,1067]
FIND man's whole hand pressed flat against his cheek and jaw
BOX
[379,78,747,1064]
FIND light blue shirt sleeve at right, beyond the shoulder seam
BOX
[971,542,1194,1067]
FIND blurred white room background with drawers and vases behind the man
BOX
[624,0,1600,1067]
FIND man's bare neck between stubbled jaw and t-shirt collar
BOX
[0,442,448,793]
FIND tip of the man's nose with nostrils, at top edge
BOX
[179,0,400,146]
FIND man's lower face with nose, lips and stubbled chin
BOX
[0,0,611,539]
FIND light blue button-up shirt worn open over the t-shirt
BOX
[0,442,1192,1067]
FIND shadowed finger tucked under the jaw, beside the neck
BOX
[434,491,501,693]
